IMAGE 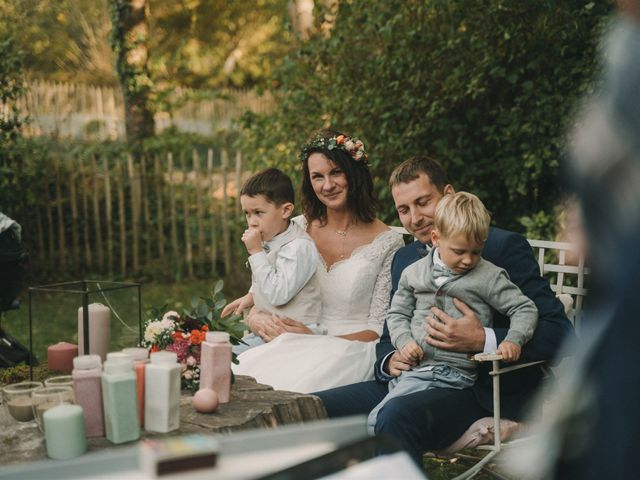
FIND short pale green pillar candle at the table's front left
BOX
[42,405,87,460]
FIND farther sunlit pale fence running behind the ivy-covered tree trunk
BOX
[18,81,273,140]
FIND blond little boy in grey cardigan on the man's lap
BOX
[368,192,538,433]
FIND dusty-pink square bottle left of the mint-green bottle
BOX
[71,355,104,437]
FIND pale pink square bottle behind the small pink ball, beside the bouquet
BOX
[200,332,231,403]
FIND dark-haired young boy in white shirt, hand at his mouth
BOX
[221,168,321,353]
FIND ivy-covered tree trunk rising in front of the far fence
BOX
[109,0,154,144]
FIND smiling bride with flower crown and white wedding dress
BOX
[233,130,404,393]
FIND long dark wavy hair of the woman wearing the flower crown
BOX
[301,129,378,224]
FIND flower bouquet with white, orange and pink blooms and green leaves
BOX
[142,280,245,391]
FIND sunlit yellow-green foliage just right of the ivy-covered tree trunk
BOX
[149,0,291,88]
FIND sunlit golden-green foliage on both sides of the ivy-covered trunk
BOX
[0,0,292,89]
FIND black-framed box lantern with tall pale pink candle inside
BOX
[28,280,143,379]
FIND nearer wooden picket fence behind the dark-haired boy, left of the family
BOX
[26,149,249,278]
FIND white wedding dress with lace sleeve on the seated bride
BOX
[233,217,404,393]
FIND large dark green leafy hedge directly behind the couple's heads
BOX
[241,0,612,228]
